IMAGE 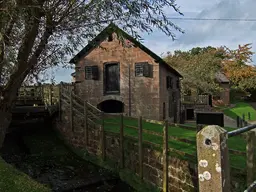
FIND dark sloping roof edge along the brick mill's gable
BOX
[70,23,182,77]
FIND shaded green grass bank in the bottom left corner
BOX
[0,157,50,192]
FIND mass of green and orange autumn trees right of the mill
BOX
[165,44,256,97]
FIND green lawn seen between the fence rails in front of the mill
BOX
[104,117,246,169]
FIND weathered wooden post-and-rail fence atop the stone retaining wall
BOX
[59,82,201,191]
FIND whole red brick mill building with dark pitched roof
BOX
[70,24,182,122]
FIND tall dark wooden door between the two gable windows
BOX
[104,63,120,94]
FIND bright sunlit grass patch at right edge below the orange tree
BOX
[223,102,256,121]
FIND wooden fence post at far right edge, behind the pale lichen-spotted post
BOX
[246,130,256,186]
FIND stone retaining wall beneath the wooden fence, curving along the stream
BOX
[56,99,197,192]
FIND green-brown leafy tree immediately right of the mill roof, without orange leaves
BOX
[165,47,221,94]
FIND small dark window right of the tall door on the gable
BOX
[135,62,153,77]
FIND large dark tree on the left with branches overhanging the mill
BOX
[0,0,183,146]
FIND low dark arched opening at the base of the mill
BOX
[97,99,124,113]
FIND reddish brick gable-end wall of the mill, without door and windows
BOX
[73,34,179,120]
